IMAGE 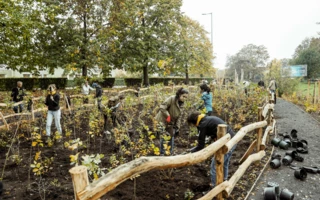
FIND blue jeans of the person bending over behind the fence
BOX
[210,145,237,187]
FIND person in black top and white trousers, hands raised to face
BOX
[45,84,62,137]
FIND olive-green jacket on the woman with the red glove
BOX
[155,95,184,129]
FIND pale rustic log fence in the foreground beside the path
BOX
[69,101,276,200]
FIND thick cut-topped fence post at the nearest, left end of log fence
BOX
[69,166,89,200]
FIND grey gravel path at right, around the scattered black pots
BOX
[248,99,320,200]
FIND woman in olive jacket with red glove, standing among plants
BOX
[155,88,189,155]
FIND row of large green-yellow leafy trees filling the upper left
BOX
[0,0,214,85]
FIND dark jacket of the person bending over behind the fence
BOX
[191,115,235,152]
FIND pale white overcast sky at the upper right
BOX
[181,0,320,68]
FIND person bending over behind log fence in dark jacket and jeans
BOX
[187,111,236,186]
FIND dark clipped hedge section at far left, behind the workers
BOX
[0,78,67,91]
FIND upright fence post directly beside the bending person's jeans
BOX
[215,124,227,200]
